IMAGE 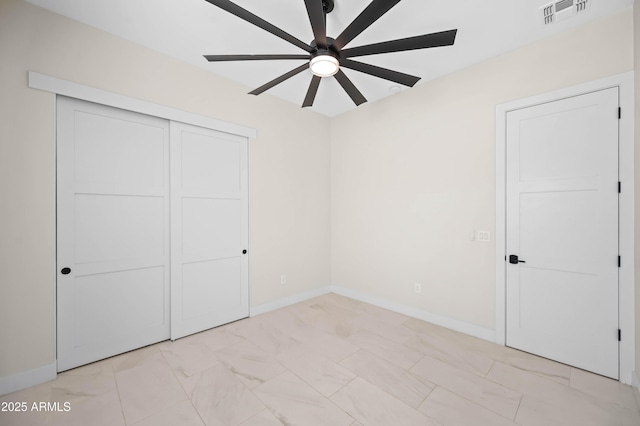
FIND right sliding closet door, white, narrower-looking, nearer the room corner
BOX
[171,122,249,339]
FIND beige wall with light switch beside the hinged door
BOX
[331,9,634,329]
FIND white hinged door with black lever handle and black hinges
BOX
[506,88,619,378]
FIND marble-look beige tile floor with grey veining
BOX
[0,294,640,426]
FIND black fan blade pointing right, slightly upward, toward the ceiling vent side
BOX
[341,30,458,58]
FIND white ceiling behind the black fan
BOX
[27,0,633,116]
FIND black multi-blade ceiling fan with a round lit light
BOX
[204,0,458,108]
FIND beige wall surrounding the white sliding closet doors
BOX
[0,0,330,378]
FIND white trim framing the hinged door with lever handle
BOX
[495,71,635,384]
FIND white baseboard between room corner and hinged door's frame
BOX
[331,286,496,342]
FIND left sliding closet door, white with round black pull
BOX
[57,97,170,371]
